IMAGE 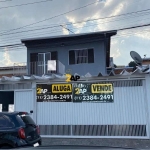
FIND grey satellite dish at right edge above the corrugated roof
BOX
[130,51,149,72]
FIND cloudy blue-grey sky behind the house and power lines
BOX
[0,0,150,67]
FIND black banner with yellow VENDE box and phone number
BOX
[73,83,114,103]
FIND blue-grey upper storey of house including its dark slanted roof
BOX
[21,31,117,76]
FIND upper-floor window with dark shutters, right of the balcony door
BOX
[69,49,94,65]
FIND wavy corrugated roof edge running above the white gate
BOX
[0,67,150,84]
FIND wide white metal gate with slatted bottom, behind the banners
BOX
[37,79,149,139]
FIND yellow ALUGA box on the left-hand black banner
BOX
[52,84,72,93]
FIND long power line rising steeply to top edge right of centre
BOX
[0,0,100,33]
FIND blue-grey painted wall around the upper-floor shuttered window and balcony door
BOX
[27,40,106,76]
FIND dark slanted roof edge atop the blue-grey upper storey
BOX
[21,30,117,43]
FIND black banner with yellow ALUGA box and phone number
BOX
[36,84,72,102]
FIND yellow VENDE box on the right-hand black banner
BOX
[91,84,113,93]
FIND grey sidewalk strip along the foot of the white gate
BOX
[42,138,150,149]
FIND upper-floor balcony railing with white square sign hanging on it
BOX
[13,60,65,76]
